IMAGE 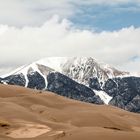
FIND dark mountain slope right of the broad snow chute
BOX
[103,77,140,112]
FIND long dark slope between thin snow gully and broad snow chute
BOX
[47,72,103,104]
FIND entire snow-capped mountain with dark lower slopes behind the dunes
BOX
[0,57,140,112]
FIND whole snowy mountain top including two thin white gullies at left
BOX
[1,57,129,87]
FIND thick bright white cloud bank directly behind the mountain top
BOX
[0,16,140,74]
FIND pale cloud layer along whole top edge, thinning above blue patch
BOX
[0,0,140,27]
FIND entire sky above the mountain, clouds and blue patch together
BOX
[0,0,140,74]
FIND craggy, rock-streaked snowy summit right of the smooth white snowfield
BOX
[56,57,129,85]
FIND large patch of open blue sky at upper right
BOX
[69,3,140,31]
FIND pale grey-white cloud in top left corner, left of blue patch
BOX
[0,0,74,27]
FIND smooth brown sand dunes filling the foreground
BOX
[0,85,140,140]
